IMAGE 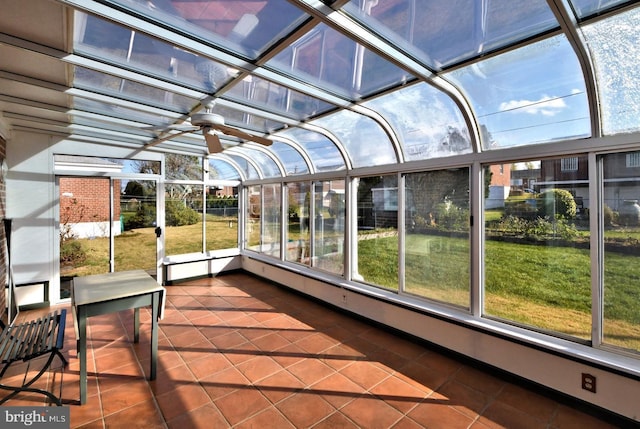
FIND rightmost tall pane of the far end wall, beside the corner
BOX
[205,185,238,251]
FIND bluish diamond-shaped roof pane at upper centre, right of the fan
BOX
[266,24,414,99]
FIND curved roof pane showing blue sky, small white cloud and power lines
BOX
[443,35,591,149]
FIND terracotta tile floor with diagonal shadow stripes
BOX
[0,273,614,429]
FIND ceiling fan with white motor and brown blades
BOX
[146,104,273,154]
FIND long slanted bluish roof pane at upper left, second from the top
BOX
[74,12,237,93]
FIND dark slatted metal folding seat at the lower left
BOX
[0,309,67,406]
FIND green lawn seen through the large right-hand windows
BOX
[358,234,640,350]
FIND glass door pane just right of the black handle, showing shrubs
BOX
[164,184,203,256]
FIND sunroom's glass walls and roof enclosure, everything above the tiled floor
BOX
[0,0,640,422]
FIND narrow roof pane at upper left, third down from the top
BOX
[73,66,200,113]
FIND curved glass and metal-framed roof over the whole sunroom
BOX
[0,0,640,180]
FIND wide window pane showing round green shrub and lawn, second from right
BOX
[484,156,595,340]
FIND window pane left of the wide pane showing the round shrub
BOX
[404,168,471,308]
